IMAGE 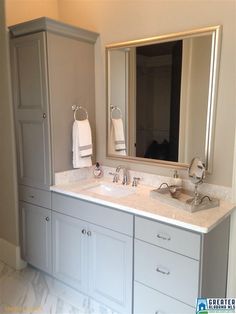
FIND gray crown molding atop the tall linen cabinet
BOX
[9,17,99,43]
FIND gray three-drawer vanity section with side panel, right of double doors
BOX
[134,216,229,314]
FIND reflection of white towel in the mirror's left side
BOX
[111,119,126,155]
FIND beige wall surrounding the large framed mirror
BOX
[58,0,236,186]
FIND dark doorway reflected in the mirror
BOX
[136,40,183,161]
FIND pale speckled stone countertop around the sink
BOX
[51,179,234,233]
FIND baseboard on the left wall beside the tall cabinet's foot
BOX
[0,239,27,270]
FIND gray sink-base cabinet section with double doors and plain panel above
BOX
[52,193,133,314]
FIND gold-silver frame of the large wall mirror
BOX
[105,25,222,173]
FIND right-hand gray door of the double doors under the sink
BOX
[88,224,133,313]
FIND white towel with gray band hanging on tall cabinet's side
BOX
[72,119,92,168]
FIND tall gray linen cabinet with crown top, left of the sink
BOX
[9,17,98,273]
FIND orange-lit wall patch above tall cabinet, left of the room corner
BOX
[5,0,58,25]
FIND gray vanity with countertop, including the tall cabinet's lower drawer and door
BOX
[20,179,232,314]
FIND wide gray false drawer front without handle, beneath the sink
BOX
[52,193,133,236]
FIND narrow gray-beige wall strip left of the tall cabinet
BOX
[0,1,19,245]
